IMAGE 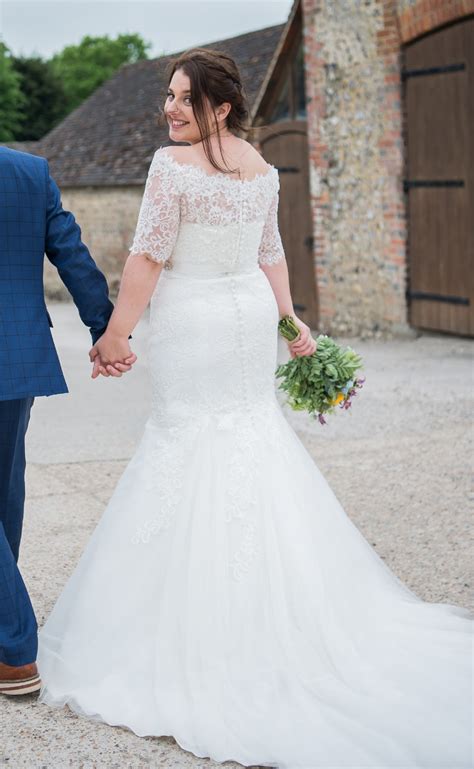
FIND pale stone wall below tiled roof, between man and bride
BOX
[44,187,143,299]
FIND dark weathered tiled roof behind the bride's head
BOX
[34,24,285,187]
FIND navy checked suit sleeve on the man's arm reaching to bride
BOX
[45,163,113,344]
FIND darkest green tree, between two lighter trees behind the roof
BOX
[12,56,64,141]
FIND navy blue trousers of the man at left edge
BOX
[0,398,38,665]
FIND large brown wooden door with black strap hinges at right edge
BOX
[403,18,474,335]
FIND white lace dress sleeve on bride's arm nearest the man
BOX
[130,149,180,262]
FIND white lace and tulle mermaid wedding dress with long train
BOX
[38,147,473,769]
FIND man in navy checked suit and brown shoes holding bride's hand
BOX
[0,147,136,695]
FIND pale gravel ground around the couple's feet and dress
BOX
[0,305,474,769]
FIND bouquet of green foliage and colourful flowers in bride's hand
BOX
[275,315,365,425]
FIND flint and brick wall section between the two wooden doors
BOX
[302,0,474,334]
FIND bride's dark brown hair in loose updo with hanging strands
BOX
[161,48,253,173]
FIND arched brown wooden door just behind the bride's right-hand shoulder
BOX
[259,120,319,329]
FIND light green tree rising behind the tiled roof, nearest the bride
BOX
[51,34,151,114]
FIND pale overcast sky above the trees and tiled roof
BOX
[0,0,292,58]
